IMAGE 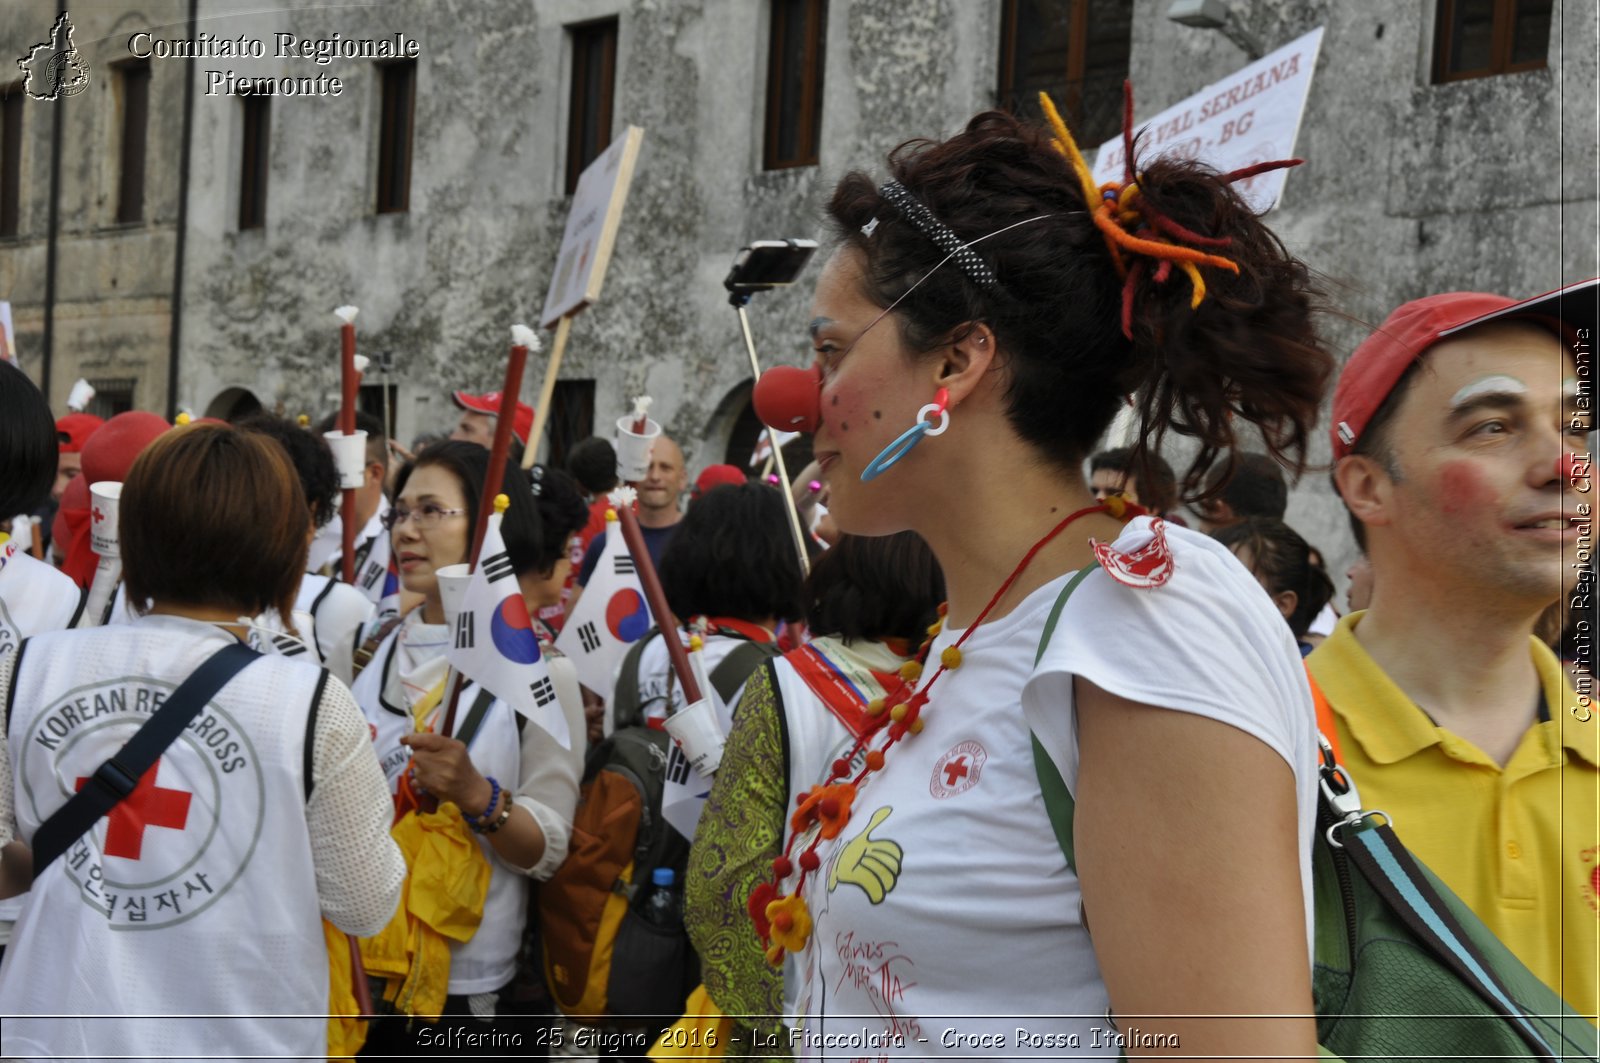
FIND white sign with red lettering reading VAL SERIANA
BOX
[1094,27,1322,213]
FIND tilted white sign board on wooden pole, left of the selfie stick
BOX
[539,125,645,328]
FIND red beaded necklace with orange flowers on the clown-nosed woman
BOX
[747,496,1144,964]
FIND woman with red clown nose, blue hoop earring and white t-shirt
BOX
[750,101,1333,1058]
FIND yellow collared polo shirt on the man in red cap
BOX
[1306,613,1600,1021]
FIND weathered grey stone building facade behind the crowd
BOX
[0,0,1600,572]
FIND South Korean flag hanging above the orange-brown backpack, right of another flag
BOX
[555,496,651,704]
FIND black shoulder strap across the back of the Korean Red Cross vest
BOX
[34,642,261,880]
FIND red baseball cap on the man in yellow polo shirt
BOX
[1328,277,1600,461]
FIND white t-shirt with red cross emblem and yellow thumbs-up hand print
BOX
[794,519,1315,1058]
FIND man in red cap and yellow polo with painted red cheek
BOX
[1307,280,1600,1020]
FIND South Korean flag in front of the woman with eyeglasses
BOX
[445,514,571,749]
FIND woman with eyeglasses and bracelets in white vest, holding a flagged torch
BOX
[354,442,584,1055]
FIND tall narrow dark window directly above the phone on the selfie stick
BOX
[762,0,827,170]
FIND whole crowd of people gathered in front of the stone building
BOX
[0,93,1600,1060]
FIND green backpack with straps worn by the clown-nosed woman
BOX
[1034,567,1600,1061]
